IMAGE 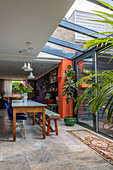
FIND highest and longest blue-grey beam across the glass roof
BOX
[59,20,105,38]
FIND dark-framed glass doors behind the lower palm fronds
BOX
[76,55,113,137]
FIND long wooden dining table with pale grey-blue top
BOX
[12,100,46,141]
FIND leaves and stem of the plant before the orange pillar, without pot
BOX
[62,65,76,117]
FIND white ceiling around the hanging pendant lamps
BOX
[0,0,74,79]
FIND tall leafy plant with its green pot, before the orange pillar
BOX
[62,65,76,126]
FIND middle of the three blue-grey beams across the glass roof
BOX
[48,37,84,52]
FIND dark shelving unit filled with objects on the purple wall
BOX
[36,69,58,104]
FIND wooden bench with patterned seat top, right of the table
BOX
[38,109,60,136]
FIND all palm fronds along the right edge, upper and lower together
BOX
[74,1,113,124]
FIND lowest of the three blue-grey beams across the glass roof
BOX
[41,46,74,59]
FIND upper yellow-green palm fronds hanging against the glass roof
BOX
[82,1,113,62]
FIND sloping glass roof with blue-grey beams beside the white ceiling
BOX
[42,0,109,60]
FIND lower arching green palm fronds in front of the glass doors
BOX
[74,70,113,123]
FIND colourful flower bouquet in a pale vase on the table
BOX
[19,80,33,103]
